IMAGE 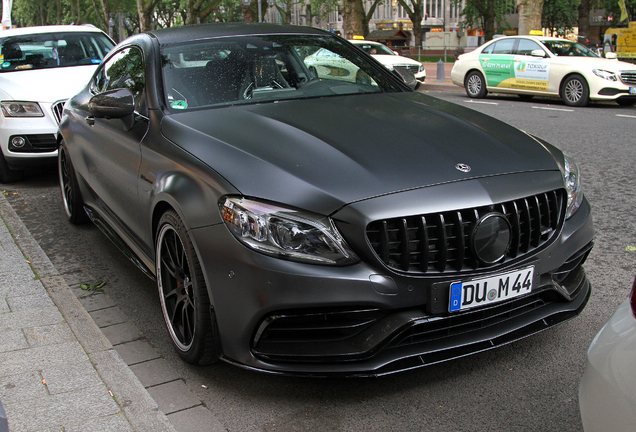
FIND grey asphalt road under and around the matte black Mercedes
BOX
[0,92,636,432]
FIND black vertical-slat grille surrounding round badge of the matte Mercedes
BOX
[367,190,565,274]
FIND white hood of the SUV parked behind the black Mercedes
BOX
[0,65,97,103]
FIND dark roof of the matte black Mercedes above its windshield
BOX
[148,23,331,44]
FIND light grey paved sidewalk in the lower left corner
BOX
[0,194,176,432]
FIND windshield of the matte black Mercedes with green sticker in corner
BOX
[162,35,404,110]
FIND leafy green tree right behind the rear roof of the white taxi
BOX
[452,0,510,40]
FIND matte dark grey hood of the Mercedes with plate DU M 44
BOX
[161,92,559,214]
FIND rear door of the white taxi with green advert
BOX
[479,38,517,90]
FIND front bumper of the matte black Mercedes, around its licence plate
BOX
[191,181,593,376]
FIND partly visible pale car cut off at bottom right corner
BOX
[579,279,636,432]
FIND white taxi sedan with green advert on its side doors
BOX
[451,36,636,106]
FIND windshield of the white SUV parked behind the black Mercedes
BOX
[0,32,114,72]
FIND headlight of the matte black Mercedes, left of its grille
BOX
[219,197,360,266]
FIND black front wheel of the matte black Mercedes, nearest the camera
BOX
[155,211,220,365]
